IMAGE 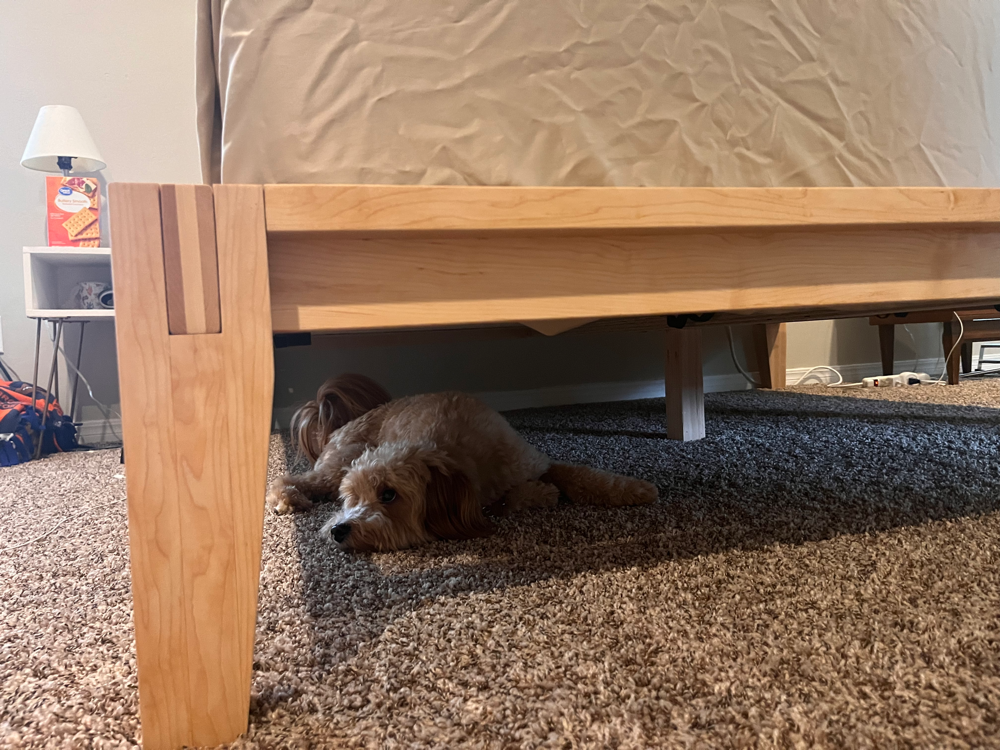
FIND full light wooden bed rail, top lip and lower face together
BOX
[264,185,1000,332]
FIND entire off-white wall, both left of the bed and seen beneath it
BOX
[0,5,952,438]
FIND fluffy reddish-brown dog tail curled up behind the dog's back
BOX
[292,374,392,463]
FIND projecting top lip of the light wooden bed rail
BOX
[264,185,1000,234]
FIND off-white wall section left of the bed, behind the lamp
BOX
[0,0,200,440]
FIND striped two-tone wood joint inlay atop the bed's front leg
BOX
[160,185,221,334]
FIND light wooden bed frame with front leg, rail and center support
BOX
[110,184,1000,748]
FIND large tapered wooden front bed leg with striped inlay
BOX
[110,184,274,748]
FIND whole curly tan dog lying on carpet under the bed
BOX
[268,375,657,551]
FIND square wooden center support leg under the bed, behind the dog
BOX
[664,328,705,440]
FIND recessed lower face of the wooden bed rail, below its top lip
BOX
[268,226,1000,331]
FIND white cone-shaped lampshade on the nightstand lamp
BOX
[21,104,108,172]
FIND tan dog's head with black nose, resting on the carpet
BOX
[320,443,491,552]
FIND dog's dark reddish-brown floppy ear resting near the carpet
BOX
[424,451,493,539]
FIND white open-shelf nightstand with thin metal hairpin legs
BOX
[23,247,115,447]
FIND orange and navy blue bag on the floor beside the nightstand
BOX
[0,380,77,466]
